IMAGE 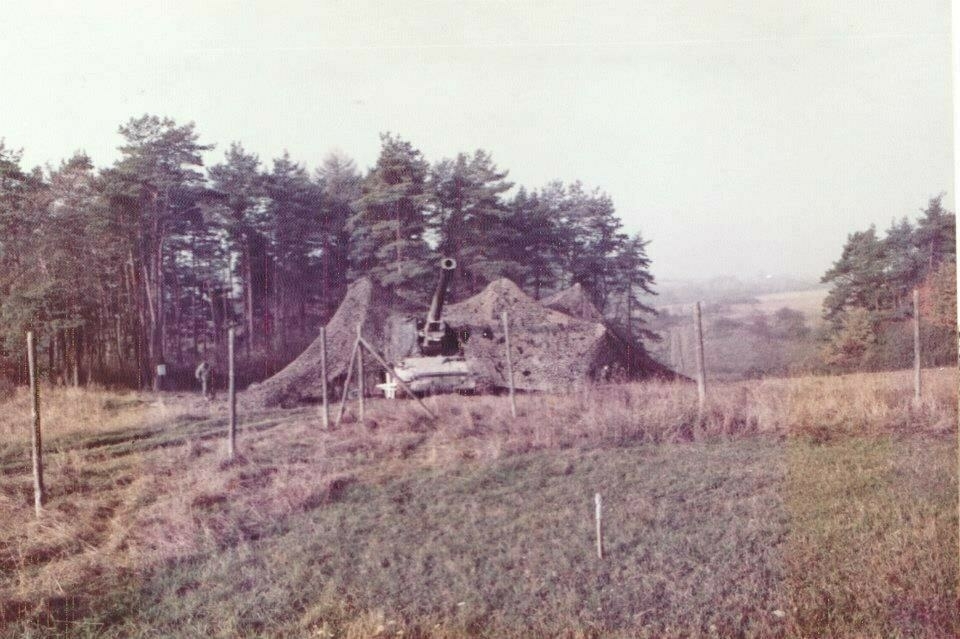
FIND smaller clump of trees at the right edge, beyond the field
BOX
[822,194,957,370]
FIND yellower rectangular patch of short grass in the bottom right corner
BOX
[785,437,960,637]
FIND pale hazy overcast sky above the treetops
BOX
[0,0,955,279]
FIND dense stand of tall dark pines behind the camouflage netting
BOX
[0,115,654,387]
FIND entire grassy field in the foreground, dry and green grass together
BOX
[0,370,960,637]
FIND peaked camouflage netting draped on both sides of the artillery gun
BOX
[248,278,676,406]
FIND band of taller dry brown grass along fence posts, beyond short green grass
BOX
[0,369,957,636]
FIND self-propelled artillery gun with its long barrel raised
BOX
[395,257,476,395]
